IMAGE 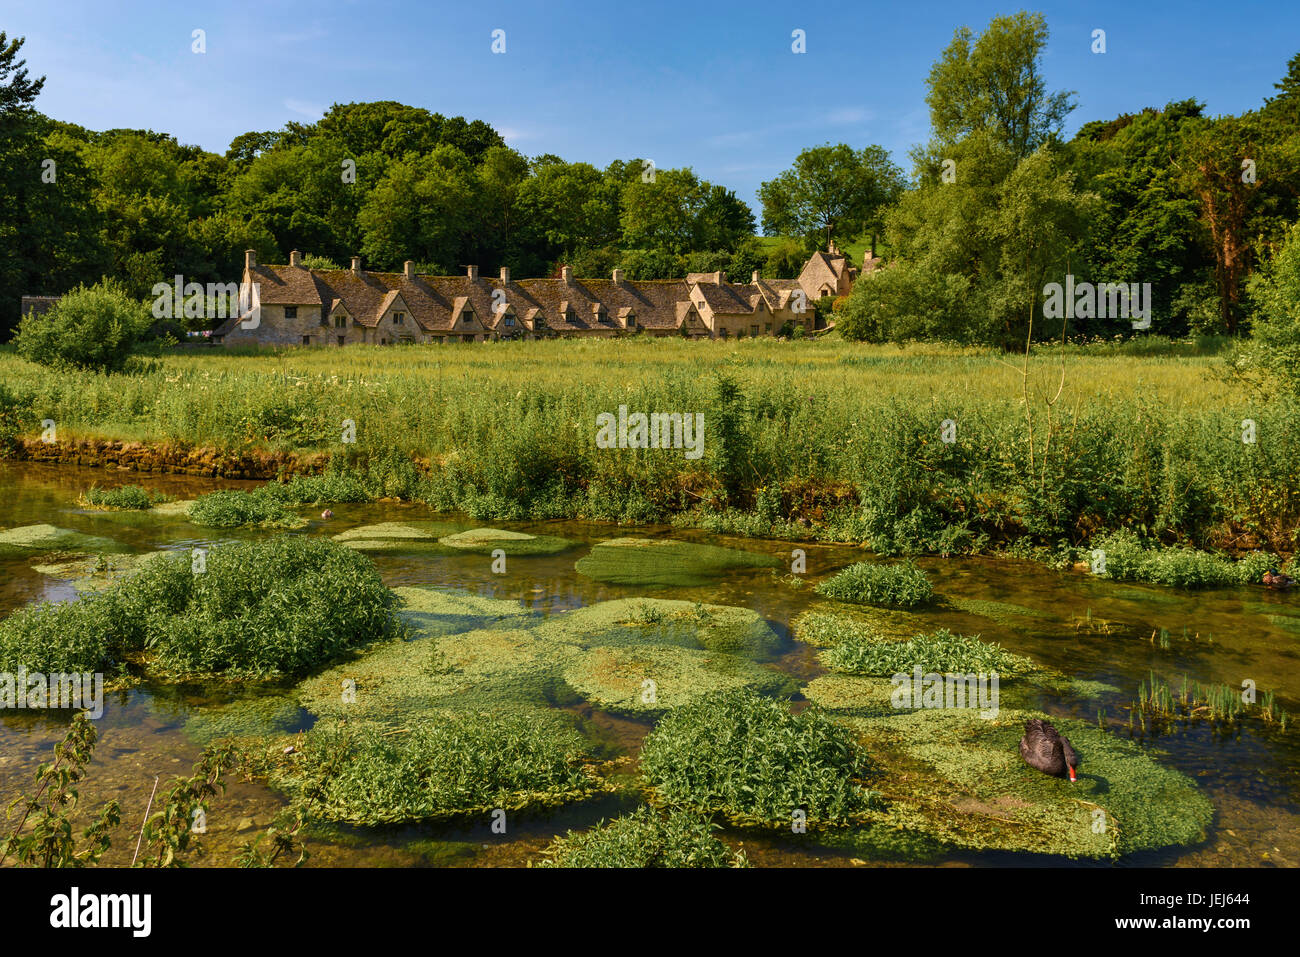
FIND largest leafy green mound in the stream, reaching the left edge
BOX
[0,537,398,677]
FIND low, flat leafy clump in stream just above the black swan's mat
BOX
[819,628,1039,677]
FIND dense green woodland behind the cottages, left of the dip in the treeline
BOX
[0,34,769,335]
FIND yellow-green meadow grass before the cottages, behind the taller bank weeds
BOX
[0,339,1240,449]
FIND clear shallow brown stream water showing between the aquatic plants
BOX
[0,463,1300,866]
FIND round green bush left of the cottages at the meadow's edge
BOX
[14,282,153,372]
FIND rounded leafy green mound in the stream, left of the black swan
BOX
[641,692,871,827]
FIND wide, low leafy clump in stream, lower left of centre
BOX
[270,710,602,824]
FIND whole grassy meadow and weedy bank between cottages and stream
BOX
[0,339,1300,553]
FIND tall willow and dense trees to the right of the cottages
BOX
[841,13,1300,346]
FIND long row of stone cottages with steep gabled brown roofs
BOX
[212,247,857,346]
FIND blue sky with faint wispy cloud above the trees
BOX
[0,0,1300,207]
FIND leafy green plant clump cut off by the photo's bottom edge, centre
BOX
[537,806,749,869]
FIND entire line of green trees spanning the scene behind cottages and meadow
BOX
[0,13,1300,346]
